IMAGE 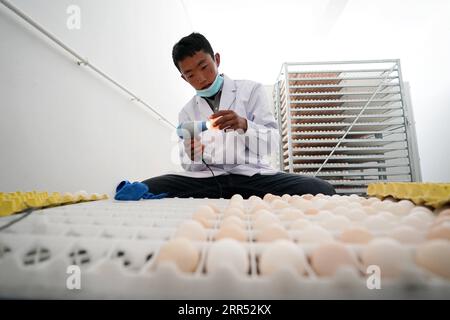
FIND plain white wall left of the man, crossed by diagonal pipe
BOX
[0,0,192,194]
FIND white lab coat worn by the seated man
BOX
[172,75,280,178]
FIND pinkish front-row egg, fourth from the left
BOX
[311,242,357,277]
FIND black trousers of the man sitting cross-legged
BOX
[142,172,335,199]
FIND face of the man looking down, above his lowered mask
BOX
[178,50,220,90]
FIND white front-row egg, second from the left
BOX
[206,239,249,274]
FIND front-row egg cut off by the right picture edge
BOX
[415,239,450,279]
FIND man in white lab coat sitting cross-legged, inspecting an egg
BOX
[143,33,335,198]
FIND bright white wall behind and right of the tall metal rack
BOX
[183,0,450,181]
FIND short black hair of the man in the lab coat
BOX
[172,32,214,71]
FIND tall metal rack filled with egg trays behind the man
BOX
[273,60,421,195]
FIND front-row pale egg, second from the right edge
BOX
[362,238,410,278]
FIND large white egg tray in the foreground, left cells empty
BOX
[0,199,450,299]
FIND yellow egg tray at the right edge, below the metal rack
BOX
[367,182,450,208]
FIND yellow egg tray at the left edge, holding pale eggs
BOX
[0,191,108,217]
